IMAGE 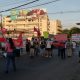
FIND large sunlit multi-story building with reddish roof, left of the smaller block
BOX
[3,9,50,38]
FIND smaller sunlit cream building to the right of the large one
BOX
[49,20,62,35]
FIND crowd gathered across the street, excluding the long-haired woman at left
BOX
[26,38,77,59]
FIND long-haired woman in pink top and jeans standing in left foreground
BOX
[5,38,16,73]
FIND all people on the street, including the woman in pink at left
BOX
[2,38,77,73]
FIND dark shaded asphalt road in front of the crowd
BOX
[0,50,80,80]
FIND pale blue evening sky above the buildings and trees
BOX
[0,0,80,28]
